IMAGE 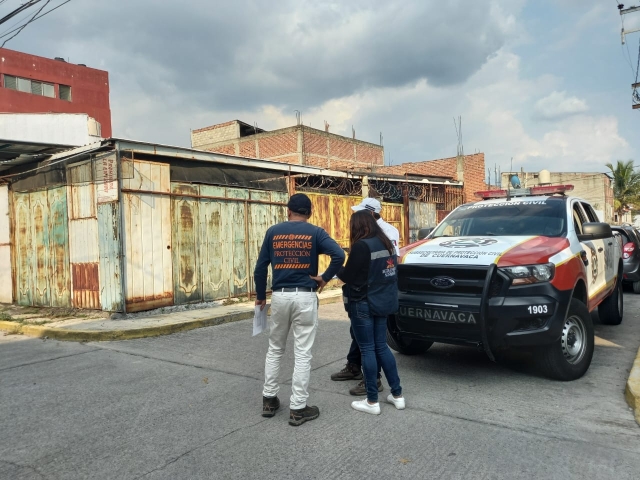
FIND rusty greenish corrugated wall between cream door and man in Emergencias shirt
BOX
[171,183,287,304]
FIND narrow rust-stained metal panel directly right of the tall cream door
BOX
[171,183,202,305]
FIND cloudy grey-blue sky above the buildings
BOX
[5,0,640,178]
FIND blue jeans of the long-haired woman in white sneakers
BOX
[349,301,402,403]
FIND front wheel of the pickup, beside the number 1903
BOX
[536,298,595,381]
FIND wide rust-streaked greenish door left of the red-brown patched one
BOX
[13,187,71,307]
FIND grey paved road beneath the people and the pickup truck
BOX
[0,293,640,480]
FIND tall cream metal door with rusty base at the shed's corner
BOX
[122,160,174,312]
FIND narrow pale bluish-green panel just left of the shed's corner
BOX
[97,202,123,312]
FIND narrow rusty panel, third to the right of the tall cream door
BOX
[228,188,249,296]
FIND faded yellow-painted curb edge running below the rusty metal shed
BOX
[0,296,342,342]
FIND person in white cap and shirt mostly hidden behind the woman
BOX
[331,198,400,396]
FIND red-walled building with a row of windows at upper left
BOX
[0,48,112,138]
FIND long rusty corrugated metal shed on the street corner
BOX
[0,139,462,312]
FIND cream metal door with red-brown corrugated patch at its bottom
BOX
[67,162,101,310]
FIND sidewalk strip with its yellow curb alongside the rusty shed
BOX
[0,289,342,342]
